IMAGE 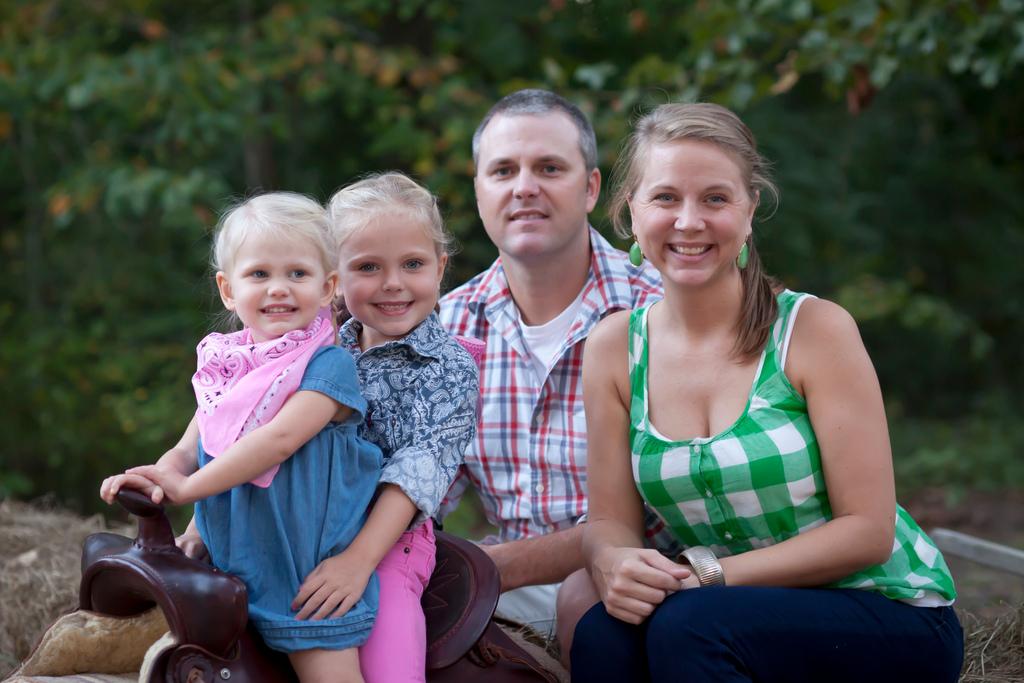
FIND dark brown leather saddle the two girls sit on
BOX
[79,489,558,683]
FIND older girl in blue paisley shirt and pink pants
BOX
[296,173,479,683]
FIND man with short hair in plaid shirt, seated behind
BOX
[440,90,679,642]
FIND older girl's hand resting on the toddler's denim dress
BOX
[292,550,374,622]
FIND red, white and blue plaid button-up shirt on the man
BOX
[440,228,679,542]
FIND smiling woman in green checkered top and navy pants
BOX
[570,103,963,683]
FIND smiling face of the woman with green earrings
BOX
[629,138,757,287]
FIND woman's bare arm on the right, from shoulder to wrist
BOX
[721,299,896,587]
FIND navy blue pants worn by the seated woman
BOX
[569,586,964,683]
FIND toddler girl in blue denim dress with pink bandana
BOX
[100,193,381,683]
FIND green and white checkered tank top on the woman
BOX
[630,290,956,606]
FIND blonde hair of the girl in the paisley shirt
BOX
[327,171,453,255]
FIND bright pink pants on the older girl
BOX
[359,519,436,683]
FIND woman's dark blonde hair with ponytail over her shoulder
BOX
[610,102,781,359]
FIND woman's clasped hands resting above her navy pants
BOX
[591,547,690,625]
